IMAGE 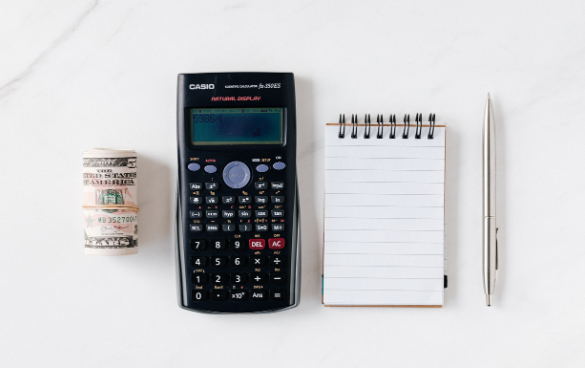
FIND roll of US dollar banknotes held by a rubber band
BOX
[83,148,138,255]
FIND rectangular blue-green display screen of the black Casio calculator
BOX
[189,107,283,145]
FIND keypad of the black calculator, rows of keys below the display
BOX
[186,158,294,309]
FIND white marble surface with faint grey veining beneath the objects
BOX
[0,0,585,368]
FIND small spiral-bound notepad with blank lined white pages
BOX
[323,114,446,307]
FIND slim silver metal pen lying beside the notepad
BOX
[482,93,498,307]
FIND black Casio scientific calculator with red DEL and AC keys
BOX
[177,73,301,313]
